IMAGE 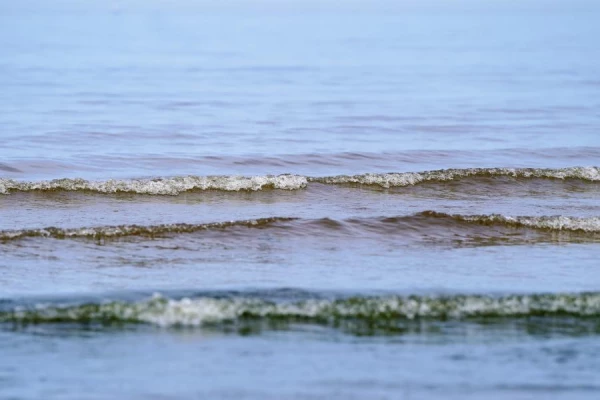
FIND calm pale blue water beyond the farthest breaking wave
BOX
[0,3,600,178]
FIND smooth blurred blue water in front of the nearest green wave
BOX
[0,324,600,400]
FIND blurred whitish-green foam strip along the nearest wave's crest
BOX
[0,292,600,327]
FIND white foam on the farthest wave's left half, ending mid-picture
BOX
[0,175,307,196]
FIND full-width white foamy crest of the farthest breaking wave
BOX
[0,167,600,196]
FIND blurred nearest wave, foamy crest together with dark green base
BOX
[0,290,600,335]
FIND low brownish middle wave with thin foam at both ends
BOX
[0,211,600,242]
